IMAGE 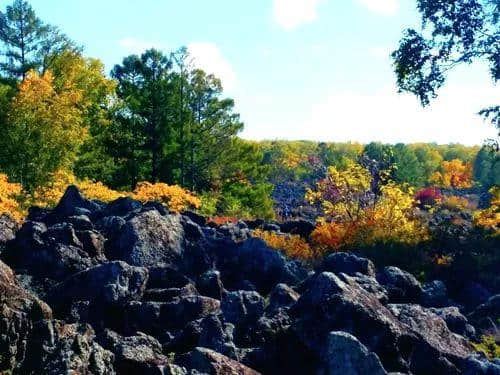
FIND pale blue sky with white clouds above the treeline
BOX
[28,0,500,145]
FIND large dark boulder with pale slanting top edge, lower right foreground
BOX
[290,272,415,371]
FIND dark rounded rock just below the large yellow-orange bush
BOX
[318,253,375,277]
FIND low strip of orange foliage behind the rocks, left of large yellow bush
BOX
[253,229,314,259]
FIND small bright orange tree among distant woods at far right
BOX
[429,159,472,189]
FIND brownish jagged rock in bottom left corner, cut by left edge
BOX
[0,261,52,373]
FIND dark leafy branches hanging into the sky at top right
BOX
[392,0,500,139]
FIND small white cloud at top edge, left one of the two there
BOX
[273,0,326,31]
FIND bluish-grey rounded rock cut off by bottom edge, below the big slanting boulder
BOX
[317,332,387,375]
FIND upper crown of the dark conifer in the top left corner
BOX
[0,0,78,80]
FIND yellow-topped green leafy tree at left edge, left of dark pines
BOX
[0,71,87,192]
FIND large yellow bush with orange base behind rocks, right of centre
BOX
[306,164,428,250]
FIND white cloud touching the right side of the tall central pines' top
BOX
[188,42,238,91]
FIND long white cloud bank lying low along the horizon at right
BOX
[244,85,500,145]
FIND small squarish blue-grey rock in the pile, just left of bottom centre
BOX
[221,291,264,325]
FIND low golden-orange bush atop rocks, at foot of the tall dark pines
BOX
[132,182,201,212]
